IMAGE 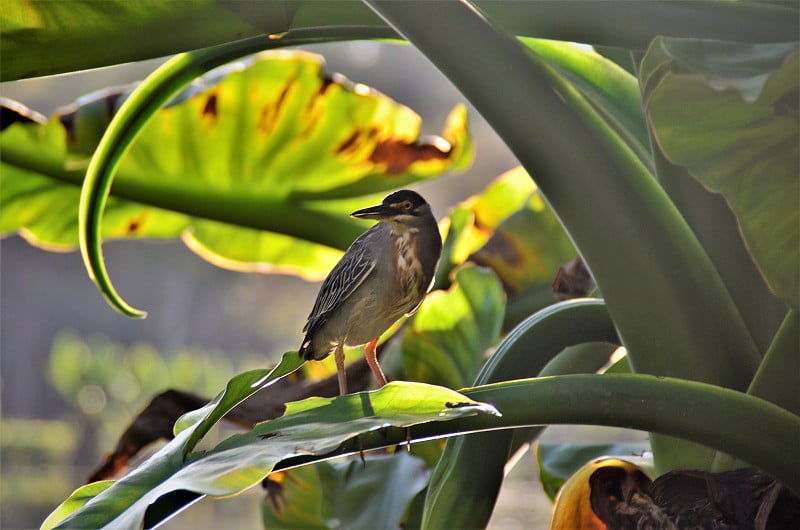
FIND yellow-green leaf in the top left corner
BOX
[0,0,282,81]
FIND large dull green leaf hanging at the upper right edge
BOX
[641,39,800,309]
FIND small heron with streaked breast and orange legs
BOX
[299,190,442,396]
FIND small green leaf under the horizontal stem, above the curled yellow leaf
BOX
[536,443,652,501]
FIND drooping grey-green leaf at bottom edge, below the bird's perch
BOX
[262,451,427,529]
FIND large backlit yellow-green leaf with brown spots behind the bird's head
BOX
[0,52,472,278]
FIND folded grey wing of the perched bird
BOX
[303,234,378,331]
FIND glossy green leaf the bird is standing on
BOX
[43,383,497,528]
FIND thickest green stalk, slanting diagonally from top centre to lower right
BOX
[367,0,760,470]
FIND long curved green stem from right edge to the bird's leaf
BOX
[358,374,800,492]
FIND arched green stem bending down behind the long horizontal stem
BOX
[422,300,619,528]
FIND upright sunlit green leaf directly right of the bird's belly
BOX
[401,266,505,388]
